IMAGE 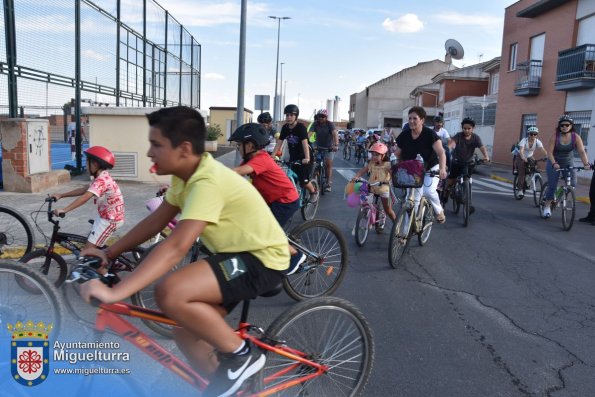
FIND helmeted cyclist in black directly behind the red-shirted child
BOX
[273,104,318,203]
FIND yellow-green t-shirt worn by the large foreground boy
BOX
[165,153,289,270]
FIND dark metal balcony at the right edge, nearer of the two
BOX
[554,44,595,91]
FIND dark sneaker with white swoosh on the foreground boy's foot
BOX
[202,340,266,397]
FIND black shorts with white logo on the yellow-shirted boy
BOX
[205,252,283,313]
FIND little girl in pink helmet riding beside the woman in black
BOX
[351,142,397,222]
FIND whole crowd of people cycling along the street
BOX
[40,104,595,396]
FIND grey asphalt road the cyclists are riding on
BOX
[2,152,595,396]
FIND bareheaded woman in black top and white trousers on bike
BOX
[395,106,446,223]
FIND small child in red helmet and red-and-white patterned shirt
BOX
[52,146,124,248]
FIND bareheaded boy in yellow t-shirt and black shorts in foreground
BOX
[81,106,289,397]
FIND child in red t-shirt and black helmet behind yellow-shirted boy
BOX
[229,123,306,274]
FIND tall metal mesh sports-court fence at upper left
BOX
[0,0,201,168]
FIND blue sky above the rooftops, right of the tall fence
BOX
[149,0,514,118]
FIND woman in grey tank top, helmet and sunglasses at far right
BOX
[542,115,591,218]
